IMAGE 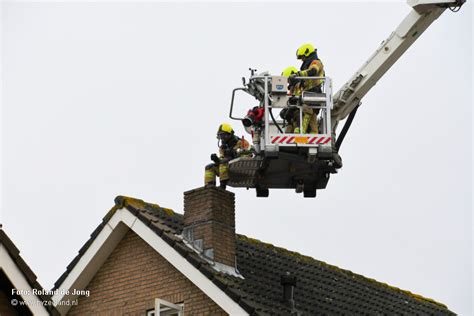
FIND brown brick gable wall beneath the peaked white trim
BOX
[68,230,227,316]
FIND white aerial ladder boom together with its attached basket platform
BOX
[227,0,465,198]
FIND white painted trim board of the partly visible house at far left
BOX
[0,244,49,315]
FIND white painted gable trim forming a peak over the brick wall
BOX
[53,208,248,315]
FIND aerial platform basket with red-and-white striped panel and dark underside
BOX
[228,74,340,197]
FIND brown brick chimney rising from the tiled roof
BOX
[183,187,235,268]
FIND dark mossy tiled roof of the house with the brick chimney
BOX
[55,196,455,315]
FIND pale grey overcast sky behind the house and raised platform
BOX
[0,1,473,315]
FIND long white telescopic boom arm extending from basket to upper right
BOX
[331,0,465,131]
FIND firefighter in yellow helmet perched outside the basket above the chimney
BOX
[204,123,250,189]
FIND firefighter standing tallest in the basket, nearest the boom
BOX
[290,43,325,133]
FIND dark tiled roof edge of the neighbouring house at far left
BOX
[0,225,59,315]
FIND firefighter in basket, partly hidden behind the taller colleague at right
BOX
[280,66,318,134]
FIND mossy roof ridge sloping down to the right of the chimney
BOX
[236,234,448,309]
